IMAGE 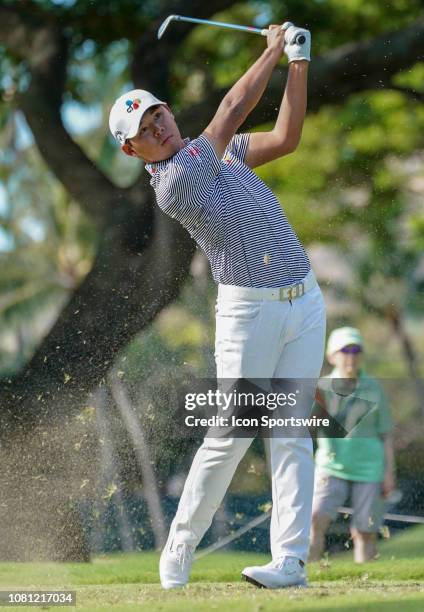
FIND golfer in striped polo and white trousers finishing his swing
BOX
[109,24,325,589]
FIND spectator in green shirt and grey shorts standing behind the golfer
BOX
[309,327,395,563]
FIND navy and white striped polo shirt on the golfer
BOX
[145,134,311,287]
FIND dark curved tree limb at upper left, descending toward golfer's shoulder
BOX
[0,2,124,227]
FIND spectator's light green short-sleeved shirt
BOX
[314,369,392,482]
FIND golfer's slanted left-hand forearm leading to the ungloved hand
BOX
[221,48,281,125]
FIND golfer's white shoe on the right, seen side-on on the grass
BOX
[241,557,308,589]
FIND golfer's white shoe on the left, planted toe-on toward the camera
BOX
[159,540,194,589]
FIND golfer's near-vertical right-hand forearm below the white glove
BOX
[273,61,309,149]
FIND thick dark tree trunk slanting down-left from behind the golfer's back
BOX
[0,207,195,439]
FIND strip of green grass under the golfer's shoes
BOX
[0,527,424,612]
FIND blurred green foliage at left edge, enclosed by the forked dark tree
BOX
[0,109,97,375]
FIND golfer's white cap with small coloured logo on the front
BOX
[109,89,166,145]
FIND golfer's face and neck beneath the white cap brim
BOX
[122,104,184,163]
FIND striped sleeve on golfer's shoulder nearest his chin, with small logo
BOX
[155,135,221,225]
